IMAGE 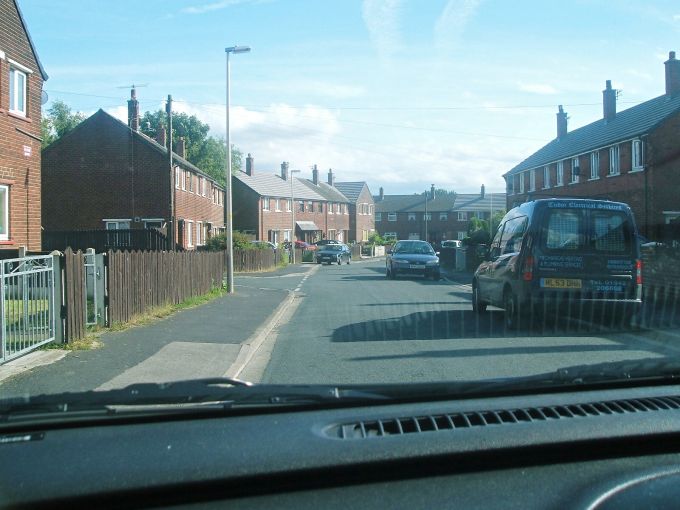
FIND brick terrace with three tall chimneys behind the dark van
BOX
[503,51,680,239]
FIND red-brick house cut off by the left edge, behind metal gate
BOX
[0,0,47,251]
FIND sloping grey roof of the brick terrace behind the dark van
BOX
[504,94,680,176]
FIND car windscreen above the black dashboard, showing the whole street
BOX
[0,0,680,422]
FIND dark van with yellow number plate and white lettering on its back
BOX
[472,199,642,329]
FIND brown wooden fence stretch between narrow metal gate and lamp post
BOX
[106,251,225,325]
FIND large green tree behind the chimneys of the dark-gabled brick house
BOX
[140,110,243,184]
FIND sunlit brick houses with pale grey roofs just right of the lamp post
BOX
[232,154,349,243]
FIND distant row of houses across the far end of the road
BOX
[374,185,505,244]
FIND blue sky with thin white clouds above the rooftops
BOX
[19,0,680,193]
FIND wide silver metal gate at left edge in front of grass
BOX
[0,255,55,363]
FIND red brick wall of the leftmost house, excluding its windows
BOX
[0,0,42,251]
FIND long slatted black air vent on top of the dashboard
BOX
[327,396,680,439]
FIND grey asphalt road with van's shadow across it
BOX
[262,260,680,383]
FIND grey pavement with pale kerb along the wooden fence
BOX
[0,264,315,397]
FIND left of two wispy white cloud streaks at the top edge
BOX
[362,0,401,59]
